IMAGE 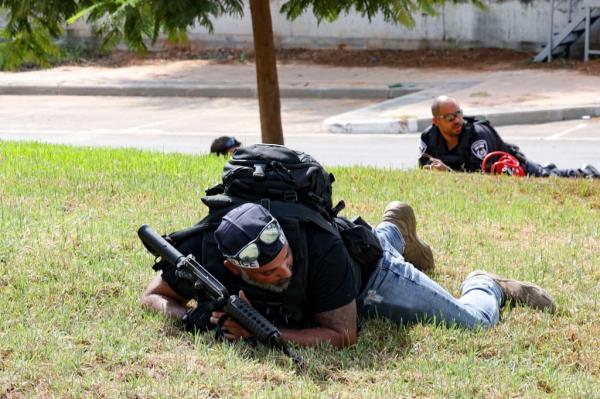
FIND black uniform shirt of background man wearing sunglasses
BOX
[419,118,516,172]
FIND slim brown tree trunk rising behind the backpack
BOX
[250,0,283,144]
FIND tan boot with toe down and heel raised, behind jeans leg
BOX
[383,201,435,273]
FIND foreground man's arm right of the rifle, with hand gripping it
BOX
[211,300,357,348]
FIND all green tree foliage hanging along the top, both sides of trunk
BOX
[0,0,481,69]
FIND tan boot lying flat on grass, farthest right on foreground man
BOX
[467,270,556,313]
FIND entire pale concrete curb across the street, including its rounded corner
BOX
[0,81,600,134]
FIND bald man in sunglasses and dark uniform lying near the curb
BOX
[419,96,600,179]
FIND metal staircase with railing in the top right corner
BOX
[533,0,600,62]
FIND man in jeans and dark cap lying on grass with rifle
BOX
[141,202,555,347]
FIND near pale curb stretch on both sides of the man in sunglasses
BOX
[323,105,600,134]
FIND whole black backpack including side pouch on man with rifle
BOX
[203,144,383,282]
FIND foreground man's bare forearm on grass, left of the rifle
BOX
[140,274,189,319]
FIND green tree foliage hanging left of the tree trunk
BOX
[0,0,243,69]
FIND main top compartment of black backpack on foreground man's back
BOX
[206,144,344,221]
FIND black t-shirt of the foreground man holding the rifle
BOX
[157,223,361,328]
